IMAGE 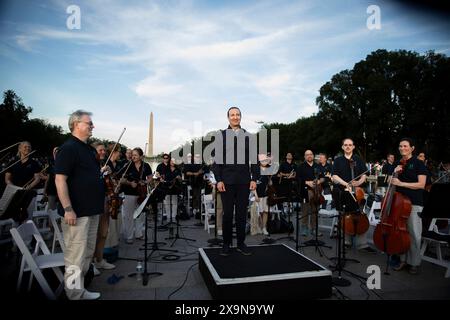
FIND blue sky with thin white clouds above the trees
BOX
[0,0,450,153]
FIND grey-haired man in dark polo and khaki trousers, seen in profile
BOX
[55,110,105,300]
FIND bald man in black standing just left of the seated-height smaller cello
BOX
[297,150,325,237]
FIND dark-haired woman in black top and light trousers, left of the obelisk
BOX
[120,148,152,244]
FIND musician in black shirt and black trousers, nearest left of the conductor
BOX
[183,154,204,219]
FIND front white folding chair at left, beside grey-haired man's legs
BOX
[10,221,64,300]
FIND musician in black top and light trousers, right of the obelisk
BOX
[161,158,182,220]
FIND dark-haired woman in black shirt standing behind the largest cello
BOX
[391,138,427,274]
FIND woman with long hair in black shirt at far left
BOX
[5,141,41,220]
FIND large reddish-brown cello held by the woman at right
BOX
[373,159,412,256]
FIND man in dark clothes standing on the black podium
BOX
[213,107,259,256]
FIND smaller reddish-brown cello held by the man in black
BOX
[341,159,369,236]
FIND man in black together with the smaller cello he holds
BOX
[332,138,376,253]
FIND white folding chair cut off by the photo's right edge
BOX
[420,218,450,278]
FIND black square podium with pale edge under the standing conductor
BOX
[199,244,332,300]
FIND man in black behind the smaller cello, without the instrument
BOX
[332,138,375,253]
